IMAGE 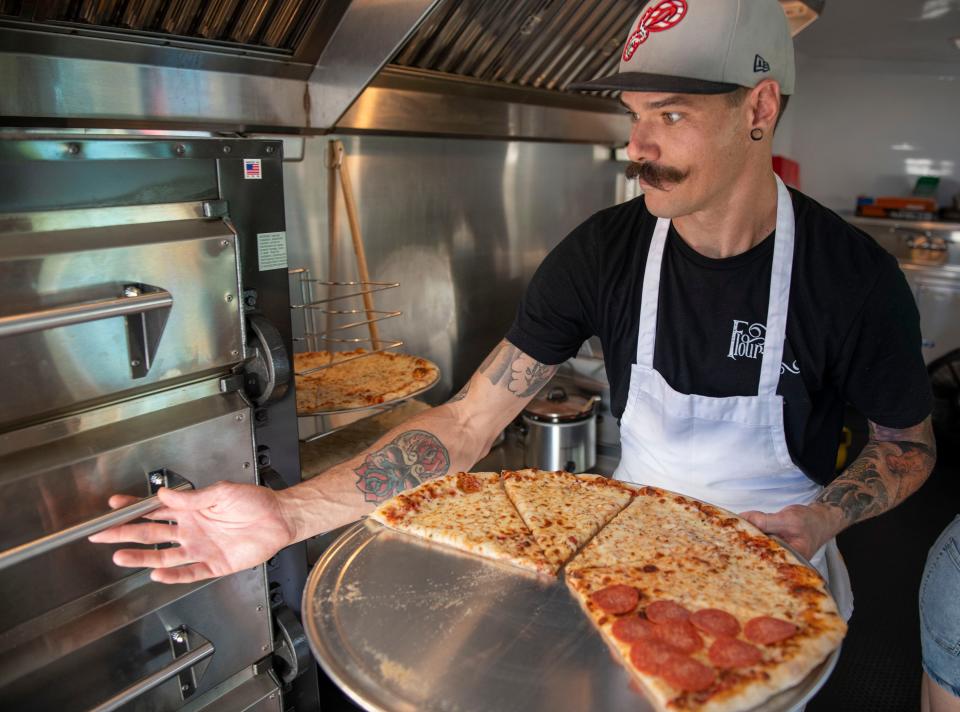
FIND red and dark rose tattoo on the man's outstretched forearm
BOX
[354,430,450,502]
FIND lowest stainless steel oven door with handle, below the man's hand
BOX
[0,567,272,712]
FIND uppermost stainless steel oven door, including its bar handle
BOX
[0,216,244,431]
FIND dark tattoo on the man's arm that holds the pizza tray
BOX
[817,418,937,524]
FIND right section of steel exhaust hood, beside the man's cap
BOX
[339,0,824,145]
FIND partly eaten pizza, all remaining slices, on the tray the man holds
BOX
[371,470,846,712]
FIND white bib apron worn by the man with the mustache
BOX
[614,178,853,619]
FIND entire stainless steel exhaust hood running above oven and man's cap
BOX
[0,0,824,144]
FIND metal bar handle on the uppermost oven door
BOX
[0,283,173,378]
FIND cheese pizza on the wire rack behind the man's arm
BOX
[293,349,440,414]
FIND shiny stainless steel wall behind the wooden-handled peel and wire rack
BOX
[284,136,623,402]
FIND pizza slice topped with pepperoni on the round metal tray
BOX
[567,559,846,712]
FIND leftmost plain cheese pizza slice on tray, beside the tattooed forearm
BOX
[370,472,557,574]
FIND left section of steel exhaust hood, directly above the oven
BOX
[0,0,437,132]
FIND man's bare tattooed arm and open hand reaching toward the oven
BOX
[91,341,556,583]
